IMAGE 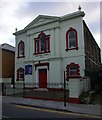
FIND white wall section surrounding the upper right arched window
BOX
[61,18,84,57]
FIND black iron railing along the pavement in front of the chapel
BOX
[2,82,68,96]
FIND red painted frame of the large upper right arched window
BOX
[66,27,78,51]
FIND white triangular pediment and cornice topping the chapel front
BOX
[13,11,85,35]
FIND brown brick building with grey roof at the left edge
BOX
[0,43,15,83]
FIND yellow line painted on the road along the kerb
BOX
[16,105,102,119]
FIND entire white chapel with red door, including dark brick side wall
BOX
[13,10,101,102]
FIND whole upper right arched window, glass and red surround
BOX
[66,27,78,50]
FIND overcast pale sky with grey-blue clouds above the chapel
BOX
[0,0,100,49]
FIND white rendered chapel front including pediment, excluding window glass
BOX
[14,11,89,102]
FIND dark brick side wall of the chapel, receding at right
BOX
[83,22,101,71]
